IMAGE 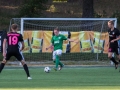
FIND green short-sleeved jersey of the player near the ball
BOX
[51,34,67,50]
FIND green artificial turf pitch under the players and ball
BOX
[0,66,120,90]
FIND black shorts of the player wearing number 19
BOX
[5,50,24,61]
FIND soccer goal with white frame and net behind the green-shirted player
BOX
[10,18,117,61]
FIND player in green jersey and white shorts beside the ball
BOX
[46,28,73,71]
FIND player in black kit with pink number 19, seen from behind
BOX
[0,24,32,79]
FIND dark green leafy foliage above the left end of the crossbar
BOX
[19,0,48,17]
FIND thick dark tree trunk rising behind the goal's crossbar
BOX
[82,0,94,18]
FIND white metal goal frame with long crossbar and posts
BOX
[9,18,117,60]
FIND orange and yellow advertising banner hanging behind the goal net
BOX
[23,30,109,53]
